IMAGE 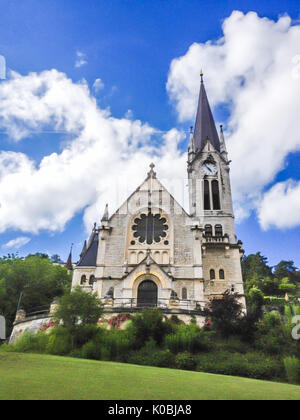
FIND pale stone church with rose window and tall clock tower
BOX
[72,74,245,325]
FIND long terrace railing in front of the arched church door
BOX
[103,298,205,311]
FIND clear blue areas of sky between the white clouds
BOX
[0,0,300,266]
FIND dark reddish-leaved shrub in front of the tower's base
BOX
[204,290,243,337]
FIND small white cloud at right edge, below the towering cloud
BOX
[258,180,300,230]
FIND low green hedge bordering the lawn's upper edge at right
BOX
[197,352,284,380]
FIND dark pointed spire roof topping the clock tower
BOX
[194,71,220,152]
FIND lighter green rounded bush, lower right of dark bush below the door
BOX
[165,324,209,354]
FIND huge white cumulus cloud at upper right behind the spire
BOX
[167,11,300,226]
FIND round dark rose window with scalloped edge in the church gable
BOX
[132,212,169,245]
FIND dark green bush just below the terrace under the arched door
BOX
[128,309,174,349]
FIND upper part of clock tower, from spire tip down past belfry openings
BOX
[187,73,236,242]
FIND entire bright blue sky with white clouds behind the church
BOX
[0,0,300,267]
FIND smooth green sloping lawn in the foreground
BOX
[0,353,300,400]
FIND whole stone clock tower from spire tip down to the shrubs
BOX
[187,72,245,304]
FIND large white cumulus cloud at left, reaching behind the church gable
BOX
[0,70,186,233]
